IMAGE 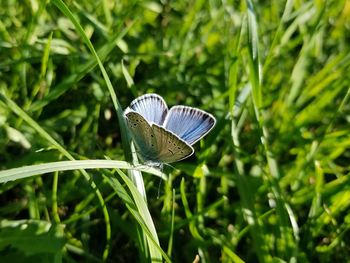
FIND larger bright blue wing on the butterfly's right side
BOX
[163,106,216,145]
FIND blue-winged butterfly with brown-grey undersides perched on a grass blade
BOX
[124,93,216,164]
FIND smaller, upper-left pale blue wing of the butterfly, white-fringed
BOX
[125,93,168,125]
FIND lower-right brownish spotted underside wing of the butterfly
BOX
[151,124,194,163]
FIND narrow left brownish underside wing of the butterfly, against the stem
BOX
[125,111,158,160]
